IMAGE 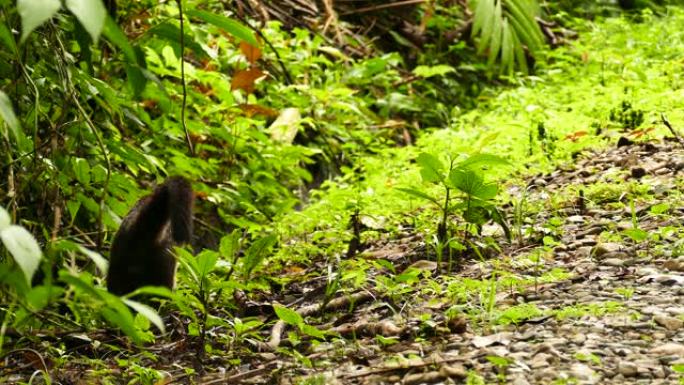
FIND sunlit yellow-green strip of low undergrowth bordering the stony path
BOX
[277,9,684,261]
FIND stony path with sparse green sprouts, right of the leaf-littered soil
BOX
[195,136,684,385]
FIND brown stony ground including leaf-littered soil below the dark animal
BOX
[5,140,684,385]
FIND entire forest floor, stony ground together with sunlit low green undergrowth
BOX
[0,12,684,385]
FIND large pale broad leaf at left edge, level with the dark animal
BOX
[0,225,43,285]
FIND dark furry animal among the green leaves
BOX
[107,176,194,295]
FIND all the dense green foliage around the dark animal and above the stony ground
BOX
[0,0,684,383]
